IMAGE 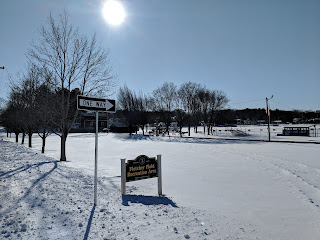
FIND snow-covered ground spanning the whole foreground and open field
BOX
[0,127,320,240]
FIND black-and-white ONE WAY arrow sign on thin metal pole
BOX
[77,95,116,113]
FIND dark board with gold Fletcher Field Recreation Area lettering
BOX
[126,155,158,182]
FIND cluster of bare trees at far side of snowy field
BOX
[117,82,229,136]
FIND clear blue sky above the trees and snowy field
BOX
[0,0,320,110]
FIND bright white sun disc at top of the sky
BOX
[102,0,126,25]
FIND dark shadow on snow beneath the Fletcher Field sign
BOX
[122,194,178,208]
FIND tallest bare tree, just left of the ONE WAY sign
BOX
[28,12,115,161]
